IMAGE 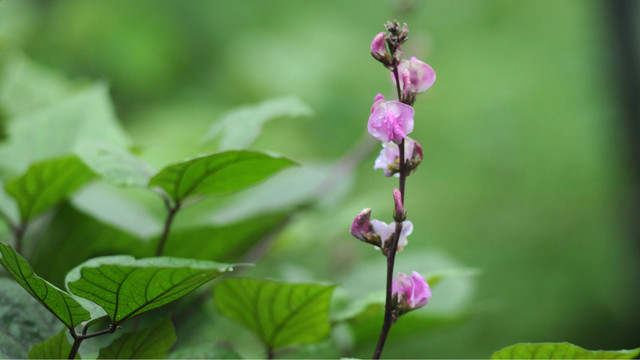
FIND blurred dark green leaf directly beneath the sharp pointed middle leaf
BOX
[160,213,289,262]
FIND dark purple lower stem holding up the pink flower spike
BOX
[373,139,407,359]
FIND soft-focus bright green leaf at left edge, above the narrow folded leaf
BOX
[5,155,95,223]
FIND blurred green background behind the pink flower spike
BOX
[0,0,640,358]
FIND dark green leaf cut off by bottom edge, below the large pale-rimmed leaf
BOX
[98,319,176,359]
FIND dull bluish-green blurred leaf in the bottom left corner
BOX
[0,277,58,359]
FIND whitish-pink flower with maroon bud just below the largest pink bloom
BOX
[373,136,422,177]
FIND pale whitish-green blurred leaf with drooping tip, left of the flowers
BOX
[202,96,313,150]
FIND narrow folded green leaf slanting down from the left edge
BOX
[0,243,90,328]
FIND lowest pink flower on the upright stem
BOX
[391,271,431,316]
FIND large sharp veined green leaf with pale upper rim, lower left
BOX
[66,256,233,324]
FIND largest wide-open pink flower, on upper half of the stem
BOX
[367,94,414,144]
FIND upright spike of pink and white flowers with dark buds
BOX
[350,21,436,324]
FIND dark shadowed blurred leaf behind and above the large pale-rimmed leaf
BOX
[29,203,153,288]
